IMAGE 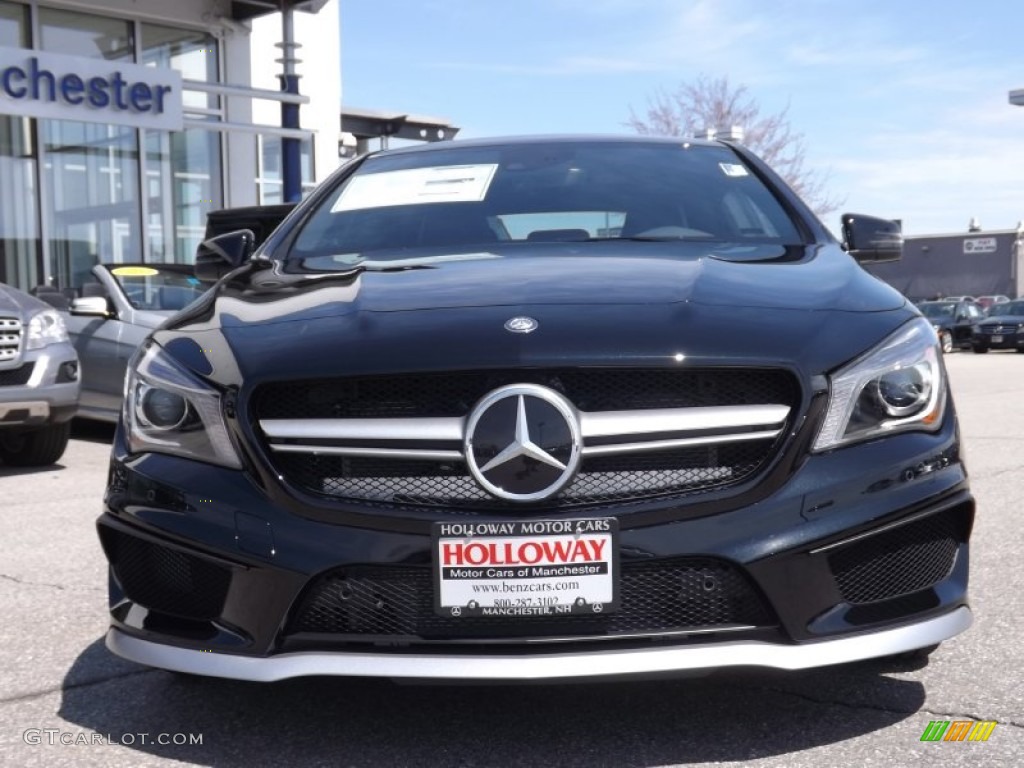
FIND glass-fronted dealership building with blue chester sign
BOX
[0,0,341,290]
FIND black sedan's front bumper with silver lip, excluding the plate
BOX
[98,399,974,680]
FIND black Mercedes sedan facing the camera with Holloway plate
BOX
[98,137,974,681]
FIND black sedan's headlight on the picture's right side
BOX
[813,318,945,452]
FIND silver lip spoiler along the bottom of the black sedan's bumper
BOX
[106,606,973,683]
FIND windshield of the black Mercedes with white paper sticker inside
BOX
[289,141,803,269]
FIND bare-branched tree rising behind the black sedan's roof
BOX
[627,75,843,216]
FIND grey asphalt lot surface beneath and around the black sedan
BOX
[0,352,1024,768]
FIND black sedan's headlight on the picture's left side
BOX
[122,344,242,469]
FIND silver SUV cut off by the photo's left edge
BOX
[0,284,81,467]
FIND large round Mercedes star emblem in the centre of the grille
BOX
[464,384,583,502]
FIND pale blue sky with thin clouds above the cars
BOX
[337,0,1024,234]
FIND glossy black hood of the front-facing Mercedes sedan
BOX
[157,243,915,383]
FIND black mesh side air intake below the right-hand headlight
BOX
[828,510,966,603]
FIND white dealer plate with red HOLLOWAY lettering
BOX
[433,517,618,618]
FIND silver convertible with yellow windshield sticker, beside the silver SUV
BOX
[62,264,206,422]
